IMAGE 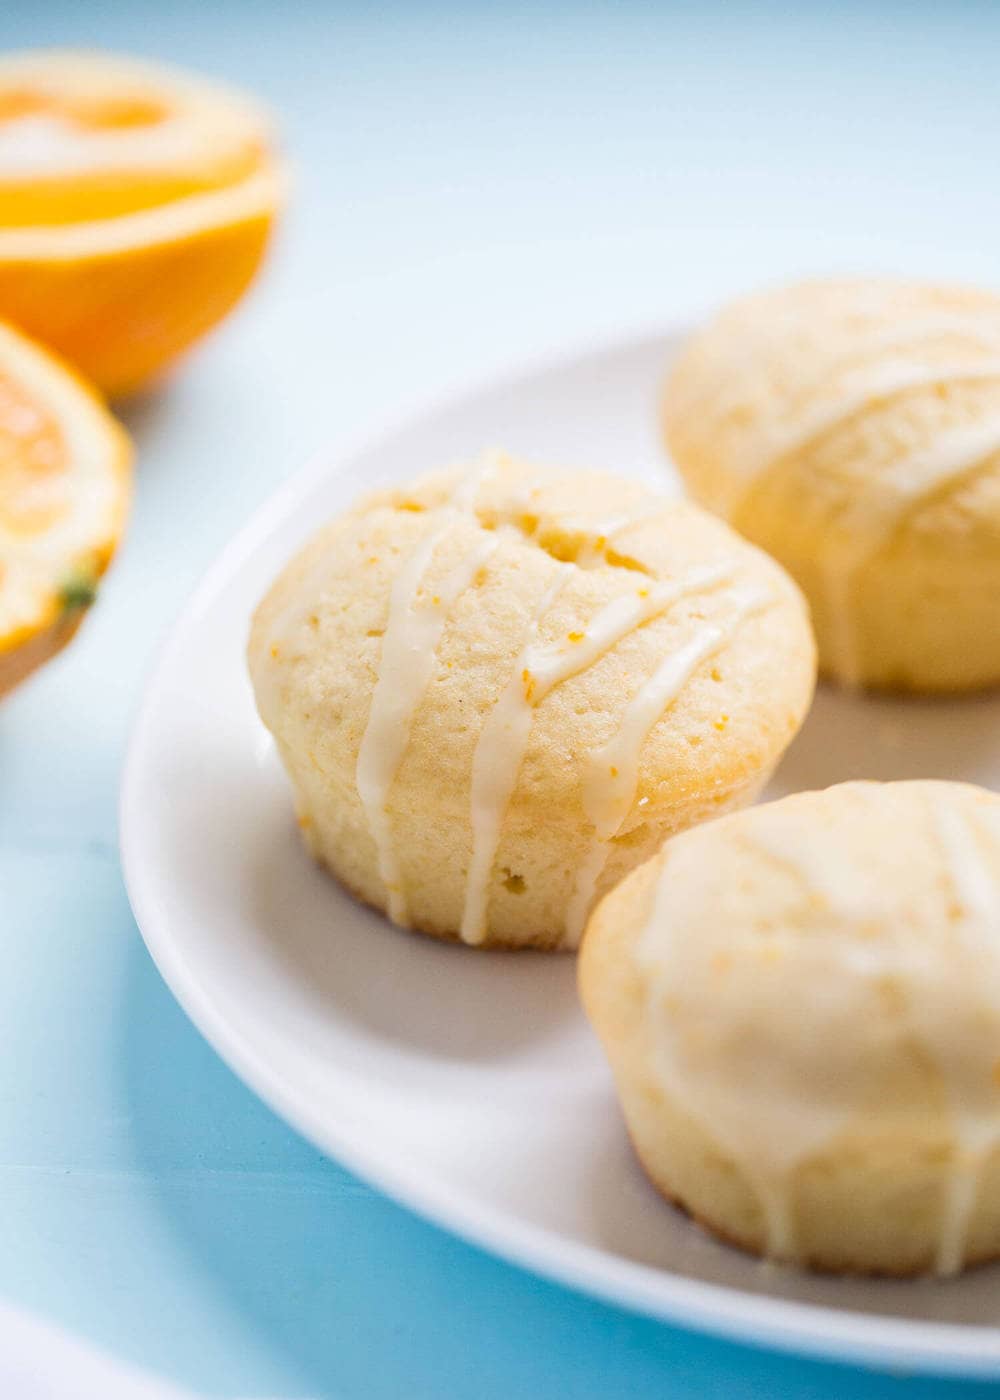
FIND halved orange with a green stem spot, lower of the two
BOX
[0,323,132,696]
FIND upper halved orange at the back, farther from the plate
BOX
[0,50,284,395]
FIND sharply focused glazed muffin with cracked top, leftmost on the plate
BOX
[249,455,815,948]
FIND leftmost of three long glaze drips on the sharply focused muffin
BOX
[354,459,497,924]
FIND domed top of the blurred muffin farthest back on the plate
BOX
[665,279,1000,556]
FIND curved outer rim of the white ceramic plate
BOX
[119,318,1000,1379]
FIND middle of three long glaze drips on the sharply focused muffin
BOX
[461,564,732,944]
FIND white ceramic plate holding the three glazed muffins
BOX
[122,324,1000,1376]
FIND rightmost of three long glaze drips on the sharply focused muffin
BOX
[566,574,770,945]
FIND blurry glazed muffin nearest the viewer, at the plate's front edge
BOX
[580,781,1000,1274]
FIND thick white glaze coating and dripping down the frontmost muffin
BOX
[639,799,1000,1274]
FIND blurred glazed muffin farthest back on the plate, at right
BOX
[664,281,1000,692]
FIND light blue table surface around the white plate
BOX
[0,0,1000,1400]
